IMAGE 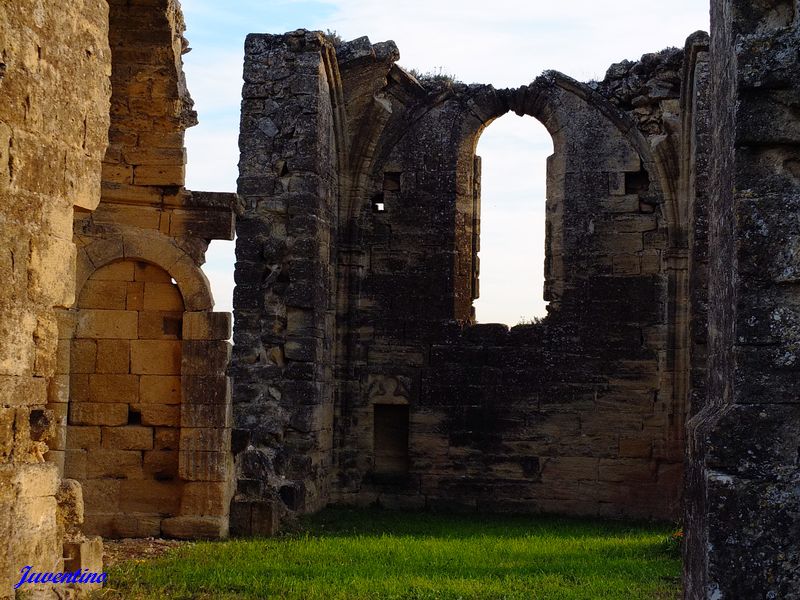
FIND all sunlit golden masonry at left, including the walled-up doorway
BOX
[0,0,238,598]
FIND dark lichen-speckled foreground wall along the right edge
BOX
[685,0,800,599]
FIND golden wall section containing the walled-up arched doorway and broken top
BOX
[63,0,237,537]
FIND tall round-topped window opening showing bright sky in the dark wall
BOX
[473,114,553,326]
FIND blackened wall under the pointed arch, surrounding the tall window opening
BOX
[333,73,682,517]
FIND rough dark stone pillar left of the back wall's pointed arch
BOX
[231,30,336,533]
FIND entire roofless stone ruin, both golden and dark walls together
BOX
[0,0,800,600]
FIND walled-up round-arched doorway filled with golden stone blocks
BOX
[65,260,184,537]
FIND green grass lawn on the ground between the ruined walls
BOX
[93,509,680,600]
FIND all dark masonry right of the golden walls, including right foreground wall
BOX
[231,0,800,599]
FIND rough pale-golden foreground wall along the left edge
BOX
[0,0,111,598]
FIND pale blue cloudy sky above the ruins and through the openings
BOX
[182,0,708,325]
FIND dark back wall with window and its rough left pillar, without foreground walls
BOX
[233,31,688,520]
